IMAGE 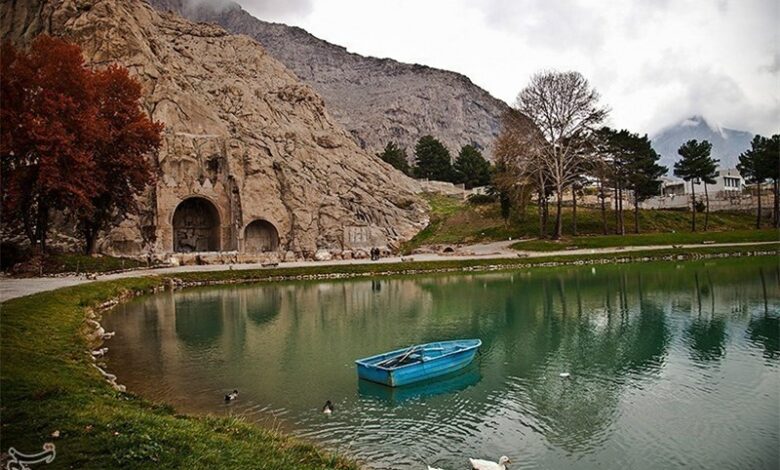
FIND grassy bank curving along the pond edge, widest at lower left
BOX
[0,245,780,469]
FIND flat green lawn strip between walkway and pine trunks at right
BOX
[512,229,780,251]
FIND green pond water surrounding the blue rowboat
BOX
[105,258,780,469]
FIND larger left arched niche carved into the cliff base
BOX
[173,197,220,253]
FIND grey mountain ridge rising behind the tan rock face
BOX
[150,0,508,158]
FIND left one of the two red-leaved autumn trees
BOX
[0,36,100,251]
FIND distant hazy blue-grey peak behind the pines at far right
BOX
[652,116,753,176]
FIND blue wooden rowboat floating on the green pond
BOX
[355,339,482,387]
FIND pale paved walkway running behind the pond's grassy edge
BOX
[0,240,777,301]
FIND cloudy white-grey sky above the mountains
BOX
[230,0,780,134]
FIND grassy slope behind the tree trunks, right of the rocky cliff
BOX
[403,195,755,253]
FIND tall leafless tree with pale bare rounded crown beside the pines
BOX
[516,71,609,238]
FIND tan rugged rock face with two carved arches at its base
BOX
[0,0,427,258]
